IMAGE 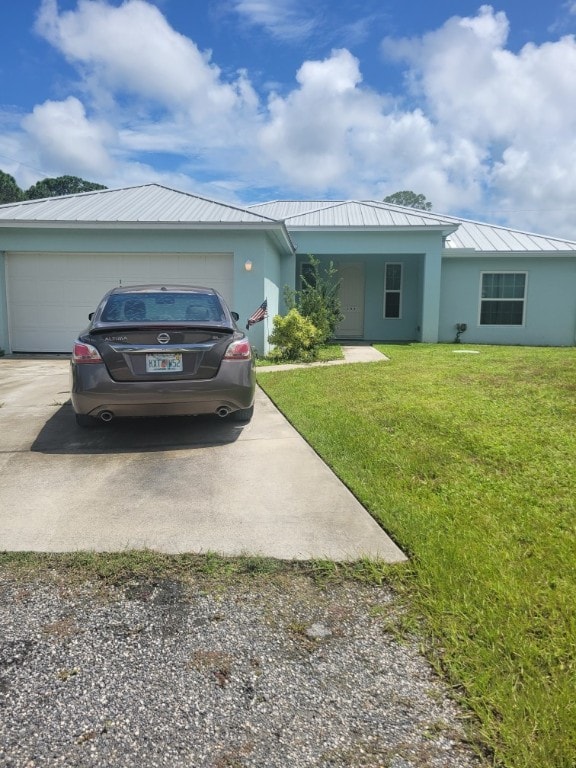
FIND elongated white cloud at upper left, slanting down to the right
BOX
[36,0,254,127]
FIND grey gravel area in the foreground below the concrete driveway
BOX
[0,574,482,768]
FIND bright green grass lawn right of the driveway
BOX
[259,344,576,768]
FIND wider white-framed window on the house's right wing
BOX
[480,272,526,325]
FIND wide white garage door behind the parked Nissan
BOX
[6,253,234,352]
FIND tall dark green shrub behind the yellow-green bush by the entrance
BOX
[284,255,343,345]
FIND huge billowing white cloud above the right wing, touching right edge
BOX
[384,6,576,231]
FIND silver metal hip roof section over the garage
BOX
[0,184,281,226]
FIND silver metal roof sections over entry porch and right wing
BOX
[250,200,576,255]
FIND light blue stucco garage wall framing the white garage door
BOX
[0,228,295,352]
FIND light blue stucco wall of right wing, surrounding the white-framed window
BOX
[440,255,576,346]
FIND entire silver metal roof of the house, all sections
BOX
[0,184,576,255]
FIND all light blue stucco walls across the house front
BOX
[0,222,576,353]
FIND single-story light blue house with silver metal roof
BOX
[0,184,576,353]
